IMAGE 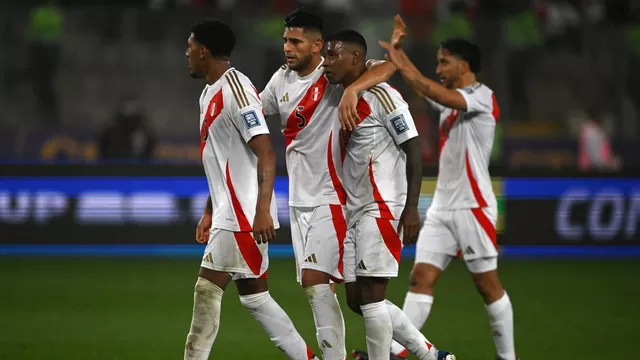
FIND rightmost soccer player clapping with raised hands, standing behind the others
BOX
[380,16,516,360]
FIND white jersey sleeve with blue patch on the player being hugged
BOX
[370,86,418,145]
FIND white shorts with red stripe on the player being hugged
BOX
[344,214,402,282]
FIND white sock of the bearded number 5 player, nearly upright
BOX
[304,284,347,360]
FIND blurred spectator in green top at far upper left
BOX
[27,1,64,124]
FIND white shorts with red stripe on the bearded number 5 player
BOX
[289,204,347,283]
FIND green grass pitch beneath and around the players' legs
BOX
[0,257,640,360]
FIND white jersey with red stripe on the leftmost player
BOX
[200,68,278,231]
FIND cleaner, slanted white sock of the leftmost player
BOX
[240,291,311,360]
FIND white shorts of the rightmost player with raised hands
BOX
[415,206,498,273]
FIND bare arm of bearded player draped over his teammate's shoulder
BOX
[338,60,396,131]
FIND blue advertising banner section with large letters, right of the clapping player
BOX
[504,178,640,245]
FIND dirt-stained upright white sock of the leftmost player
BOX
[184,277,224,360]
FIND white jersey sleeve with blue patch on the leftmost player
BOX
[229,83,269,142]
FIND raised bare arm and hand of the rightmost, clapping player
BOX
[379,15,467,111]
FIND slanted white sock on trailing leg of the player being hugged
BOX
[387,300,438,360]
